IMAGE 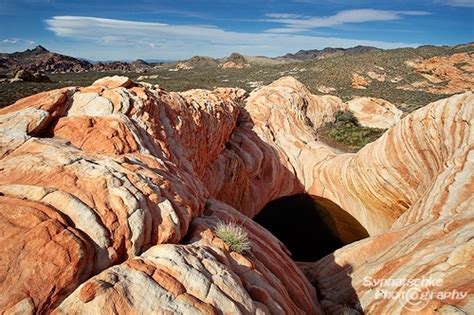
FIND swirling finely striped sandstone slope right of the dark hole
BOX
[305,92,474,314]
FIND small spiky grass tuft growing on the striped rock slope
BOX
[214,221,250,253]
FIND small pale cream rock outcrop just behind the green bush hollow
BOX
[347,97,403,129]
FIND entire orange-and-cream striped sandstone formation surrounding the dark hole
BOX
[0,77,474,314]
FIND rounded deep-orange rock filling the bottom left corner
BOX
[0,196,94,313]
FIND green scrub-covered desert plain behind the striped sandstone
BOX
[0,46,473,108]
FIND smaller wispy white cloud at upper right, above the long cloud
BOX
[266,9,430,32]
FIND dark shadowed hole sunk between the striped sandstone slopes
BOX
[253,194,369,261]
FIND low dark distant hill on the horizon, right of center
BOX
[280,46,382,60]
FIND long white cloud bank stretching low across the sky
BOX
[46,16,418,60]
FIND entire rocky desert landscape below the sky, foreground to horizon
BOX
[0,1,474,314]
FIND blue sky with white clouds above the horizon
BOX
[0,0,474,60]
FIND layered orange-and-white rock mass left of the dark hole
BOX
[0,77,320,313]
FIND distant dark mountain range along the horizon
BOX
[0,43,472,78]
